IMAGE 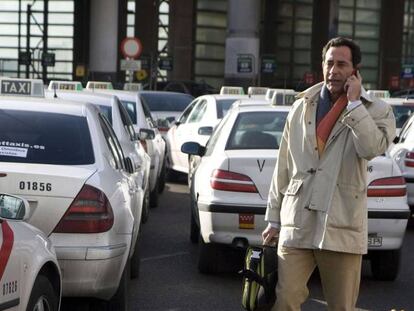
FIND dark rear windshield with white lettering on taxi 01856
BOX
[0,109,95,165]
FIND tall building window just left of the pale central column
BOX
[194,0,227,88]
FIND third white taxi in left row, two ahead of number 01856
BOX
[85,89,166,207]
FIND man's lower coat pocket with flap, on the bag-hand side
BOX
[280,179,303,227]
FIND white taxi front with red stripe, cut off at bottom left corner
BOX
[0,194,62,311]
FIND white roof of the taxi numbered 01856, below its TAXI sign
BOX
[0,96,95,116]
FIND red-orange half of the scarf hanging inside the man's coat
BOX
[316,94,348,156]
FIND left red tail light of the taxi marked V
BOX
[210,170,258,193]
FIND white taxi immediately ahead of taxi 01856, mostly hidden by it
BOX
[46,86,154,227]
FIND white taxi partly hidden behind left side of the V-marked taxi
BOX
[166,87,251,174]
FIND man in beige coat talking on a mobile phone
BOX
[262,37,395,311]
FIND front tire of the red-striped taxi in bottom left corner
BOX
[27,274,59,311]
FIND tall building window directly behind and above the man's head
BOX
[338,0,381,89]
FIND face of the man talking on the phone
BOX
[322,46,354,96]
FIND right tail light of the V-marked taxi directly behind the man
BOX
[367,176,407,197]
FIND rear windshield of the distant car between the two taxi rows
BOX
[140,93,194,112]
